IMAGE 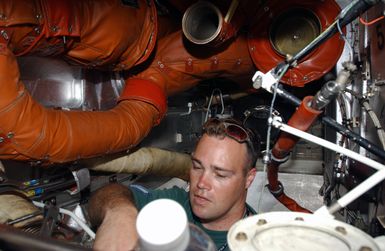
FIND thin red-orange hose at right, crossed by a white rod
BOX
[267,96,322,212]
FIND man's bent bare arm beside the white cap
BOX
[88,184,138,251]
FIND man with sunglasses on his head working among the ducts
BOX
[89,119,259,251]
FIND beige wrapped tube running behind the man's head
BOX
[85,147,192,180]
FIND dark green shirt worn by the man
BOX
[131,186,255,251]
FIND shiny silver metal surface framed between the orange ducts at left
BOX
[18,57,124,110]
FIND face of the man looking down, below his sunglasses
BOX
[190,134,255,226]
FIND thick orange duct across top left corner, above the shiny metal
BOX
[0,0,158,70]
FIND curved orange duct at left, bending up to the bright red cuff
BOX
[0,44,165,163]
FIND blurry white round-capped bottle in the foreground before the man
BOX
[136,199,190,251]
